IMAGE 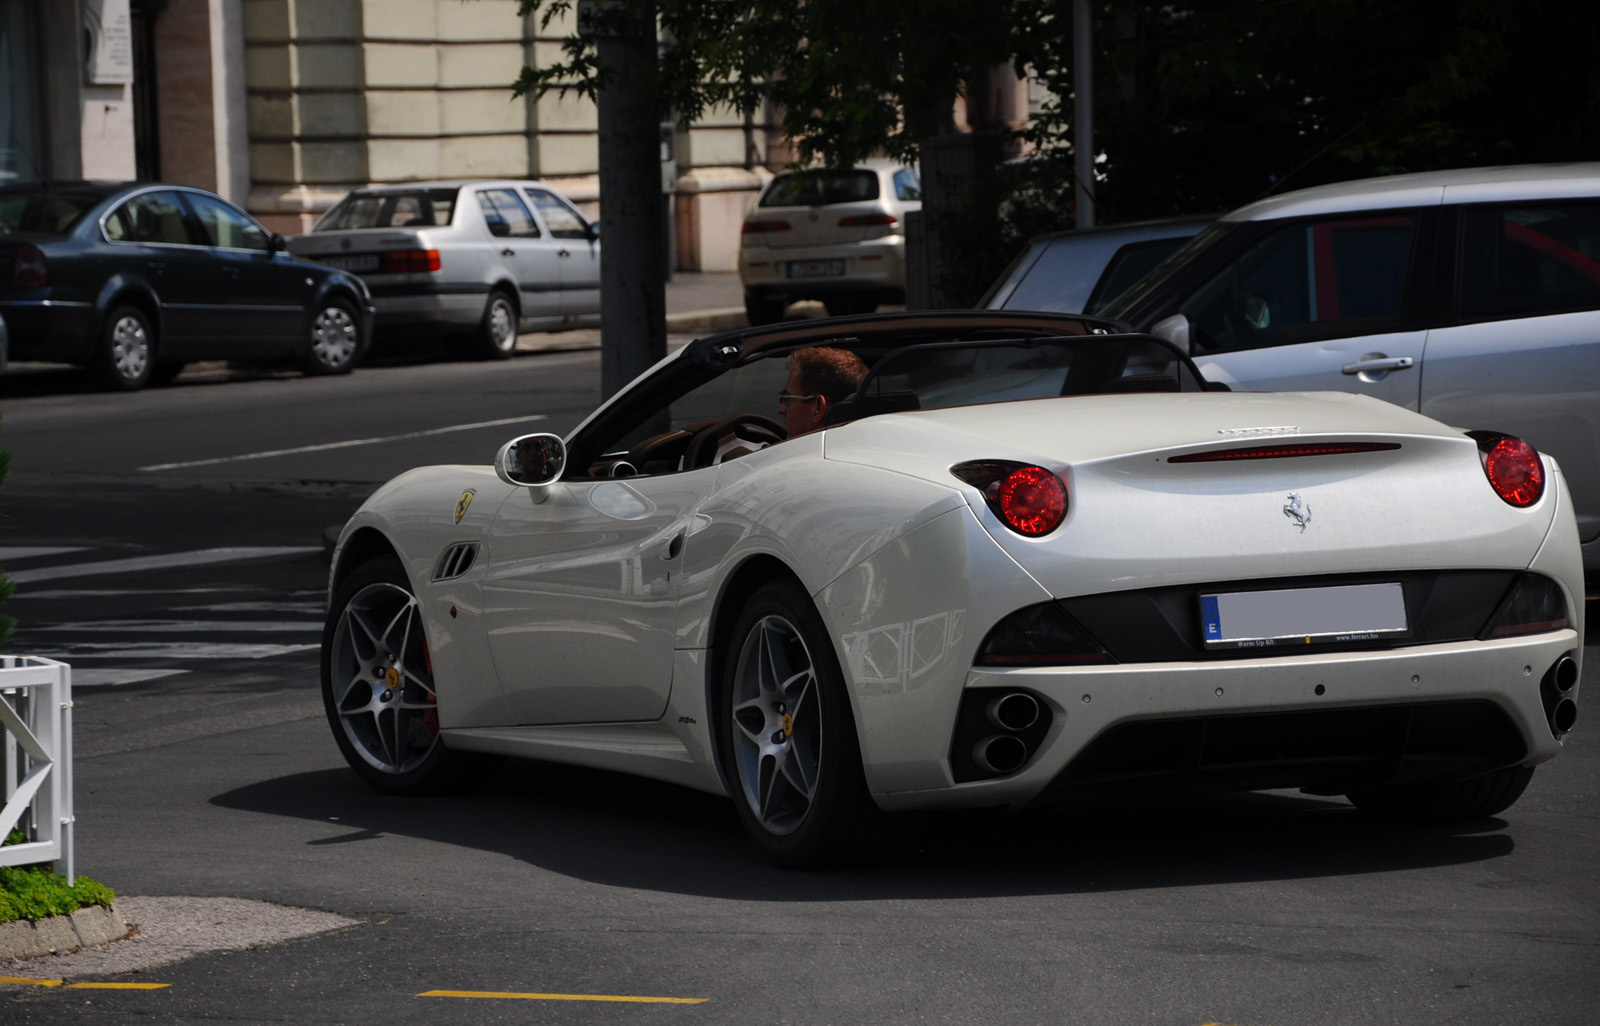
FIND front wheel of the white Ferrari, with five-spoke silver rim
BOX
[322,555,499,794]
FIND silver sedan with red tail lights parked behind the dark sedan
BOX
[290,179,600,359]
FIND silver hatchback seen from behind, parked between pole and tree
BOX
[739,160,922,325]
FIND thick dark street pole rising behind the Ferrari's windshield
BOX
[595,0,667,399]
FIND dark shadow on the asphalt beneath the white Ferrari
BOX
[213,760,1514,901]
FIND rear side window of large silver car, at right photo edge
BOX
[1461,200,1600,320]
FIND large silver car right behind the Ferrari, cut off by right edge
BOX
[1101,163,1600,582]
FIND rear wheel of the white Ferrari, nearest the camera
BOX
[715,579,894,869]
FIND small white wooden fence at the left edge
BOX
[0,656,72,884]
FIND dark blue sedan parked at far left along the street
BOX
[0,182,373,391]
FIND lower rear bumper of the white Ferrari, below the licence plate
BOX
[874,629,1582,810]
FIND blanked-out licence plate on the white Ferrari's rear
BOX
[1200,584,1408,648]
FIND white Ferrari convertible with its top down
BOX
[322,312,1584,866]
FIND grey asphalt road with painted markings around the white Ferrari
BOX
[0,352,1600,1026]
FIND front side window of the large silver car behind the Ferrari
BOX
[1178,213,1416,352]
